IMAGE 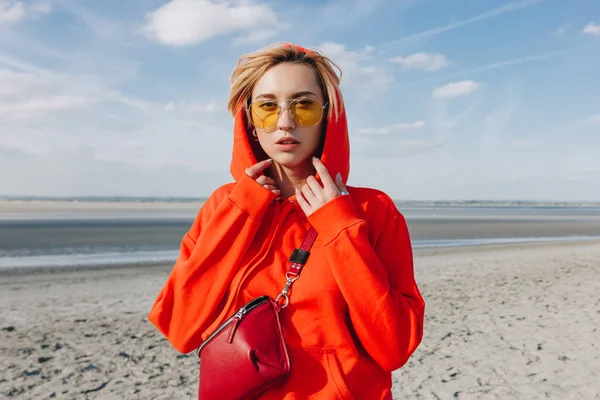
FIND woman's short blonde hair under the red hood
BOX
[227,43,344,122]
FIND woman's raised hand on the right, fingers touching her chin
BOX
[296,158,348,217]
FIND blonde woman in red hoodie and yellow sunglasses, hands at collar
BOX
[149,44,425,400]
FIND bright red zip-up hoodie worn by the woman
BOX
[149,73,425,400]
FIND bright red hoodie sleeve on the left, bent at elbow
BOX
[148,175,275,353]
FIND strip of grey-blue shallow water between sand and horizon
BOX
[0,206,600,269]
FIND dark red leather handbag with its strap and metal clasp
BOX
[197,227,317,400]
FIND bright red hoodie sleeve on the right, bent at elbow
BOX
[308,192,425,371]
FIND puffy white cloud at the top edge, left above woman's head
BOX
[141,0,281,46]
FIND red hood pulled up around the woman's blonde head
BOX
[230,44,350,188]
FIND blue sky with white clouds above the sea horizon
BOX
[0,0,600,201]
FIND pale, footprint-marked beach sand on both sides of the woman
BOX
[0,242,600,400]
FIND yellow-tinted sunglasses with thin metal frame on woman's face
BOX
[247,99,327,129]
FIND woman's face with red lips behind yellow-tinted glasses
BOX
[251,63,327,169]
